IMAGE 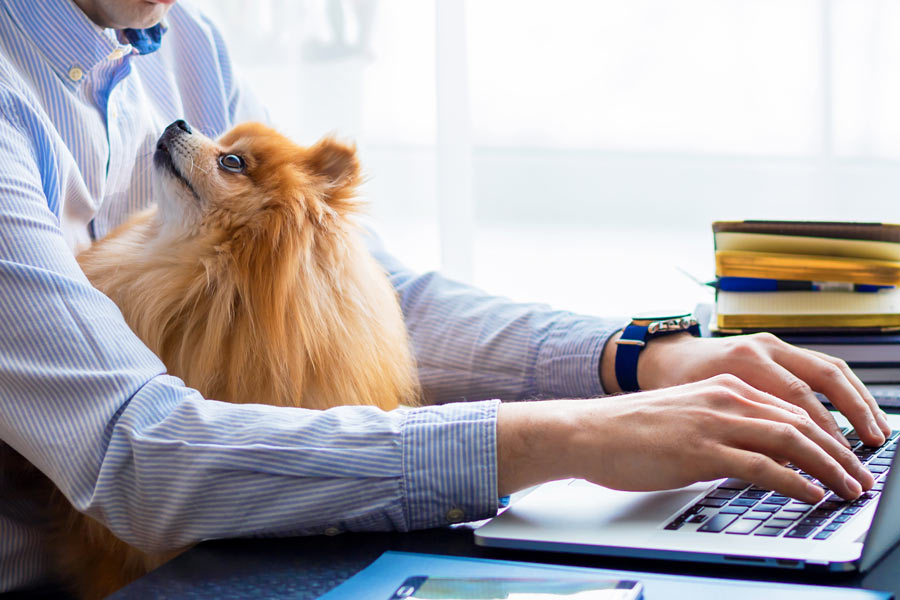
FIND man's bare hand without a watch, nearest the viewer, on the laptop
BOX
[497,375,874,502]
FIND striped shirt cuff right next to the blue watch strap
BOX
[535,314,622,398]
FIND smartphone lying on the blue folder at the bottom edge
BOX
[388,575,643,600]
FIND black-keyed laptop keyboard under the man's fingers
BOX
[664,429,900,540]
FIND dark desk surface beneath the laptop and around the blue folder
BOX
[111,529,900,600]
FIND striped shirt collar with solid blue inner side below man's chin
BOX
[2,0,166,87]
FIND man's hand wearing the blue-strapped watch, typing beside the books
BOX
[601,333,891,446]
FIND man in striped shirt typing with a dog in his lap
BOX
[0,0,889,591]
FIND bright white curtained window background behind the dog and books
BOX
[195,0,900,315]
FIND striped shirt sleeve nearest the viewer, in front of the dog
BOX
[0,98,497,561]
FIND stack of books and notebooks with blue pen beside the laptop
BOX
[709,221,900,383]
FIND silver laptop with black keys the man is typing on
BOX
[475,414,900,571]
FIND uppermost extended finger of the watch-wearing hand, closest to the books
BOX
[772,344,886,446]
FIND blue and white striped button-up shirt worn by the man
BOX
[0,0,617,591]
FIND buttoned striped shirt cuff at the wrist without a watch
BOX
[401,400,500,529]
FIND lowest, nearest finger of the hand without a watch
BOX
[716,446,825,504]
